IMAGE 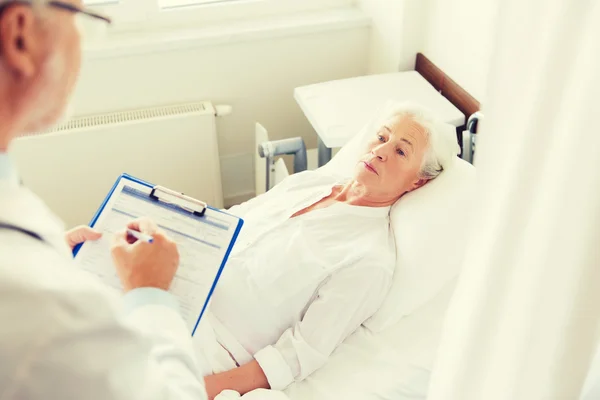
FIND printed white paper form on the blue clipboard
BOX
[75,175,243,334]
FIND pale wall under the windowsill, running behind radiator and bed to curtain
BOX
[65,0,496,206]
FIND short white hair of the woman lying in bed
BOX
[382,102,460,180]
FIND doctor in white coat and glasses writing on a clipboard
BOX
[0,0,206,400]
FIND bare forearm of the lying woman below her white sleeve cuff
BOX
[204,361,270,400]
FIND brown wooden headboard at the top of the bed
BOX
[415,53,481,121]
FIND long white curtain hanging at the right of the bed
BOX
[429,0,600,400]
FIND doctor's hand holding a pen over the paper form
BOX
[111,218,179,292]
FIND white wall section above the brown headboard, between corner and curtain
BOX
[423,0,498,102]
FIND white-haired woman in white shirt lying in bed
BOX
[197,102,455,398]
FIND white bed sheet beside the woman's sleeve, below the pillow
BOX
[285,281,455,400]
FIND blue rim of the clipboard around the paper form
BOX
[73,174,244,336]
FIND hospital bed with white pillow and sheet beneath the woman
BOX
[244,55,481,400]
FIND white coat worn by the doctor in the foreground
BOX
[0,177,206,400]
